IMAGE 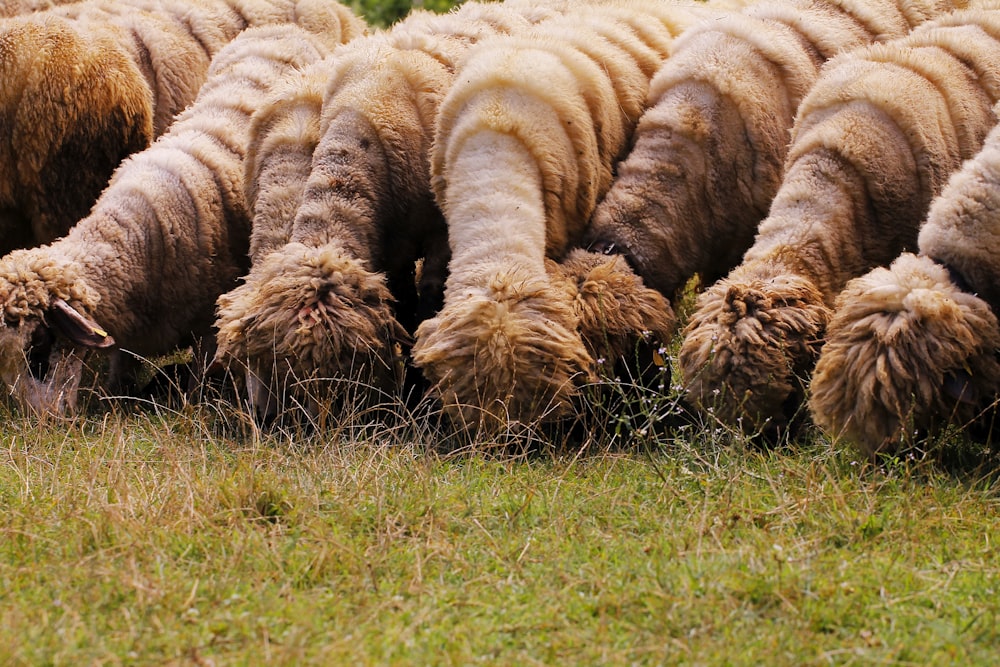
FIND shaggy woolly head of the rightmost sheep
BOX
[809,254,1000,456]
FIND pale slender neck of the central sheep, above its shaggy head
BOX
[445,130,546,283]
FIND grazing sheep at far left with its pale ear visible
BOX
[0,9,363,413]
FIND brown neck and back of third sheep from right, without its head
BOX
[587,0,954,298]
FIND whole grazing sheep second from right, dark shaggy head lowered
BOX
[679,10,1000,430]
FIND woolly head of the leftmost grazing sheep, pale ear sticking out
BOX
[0,251,114,415]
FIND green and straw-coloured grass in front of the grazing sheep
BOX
[0,392,1000,665]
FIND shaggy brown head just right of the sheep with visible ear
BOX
[214,243,408,421]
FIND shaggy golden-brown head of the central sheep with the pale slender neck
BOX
[413,272,596,430]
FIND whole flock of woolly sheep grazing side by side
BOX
[0,0,1000,454]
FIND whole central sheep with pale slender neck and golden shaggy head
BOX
[412,2,723,430]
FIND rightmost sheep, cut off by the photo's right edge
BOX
[809,102,1000,457]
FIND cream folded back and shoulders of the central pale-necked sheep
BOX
[431,2,717,256]
